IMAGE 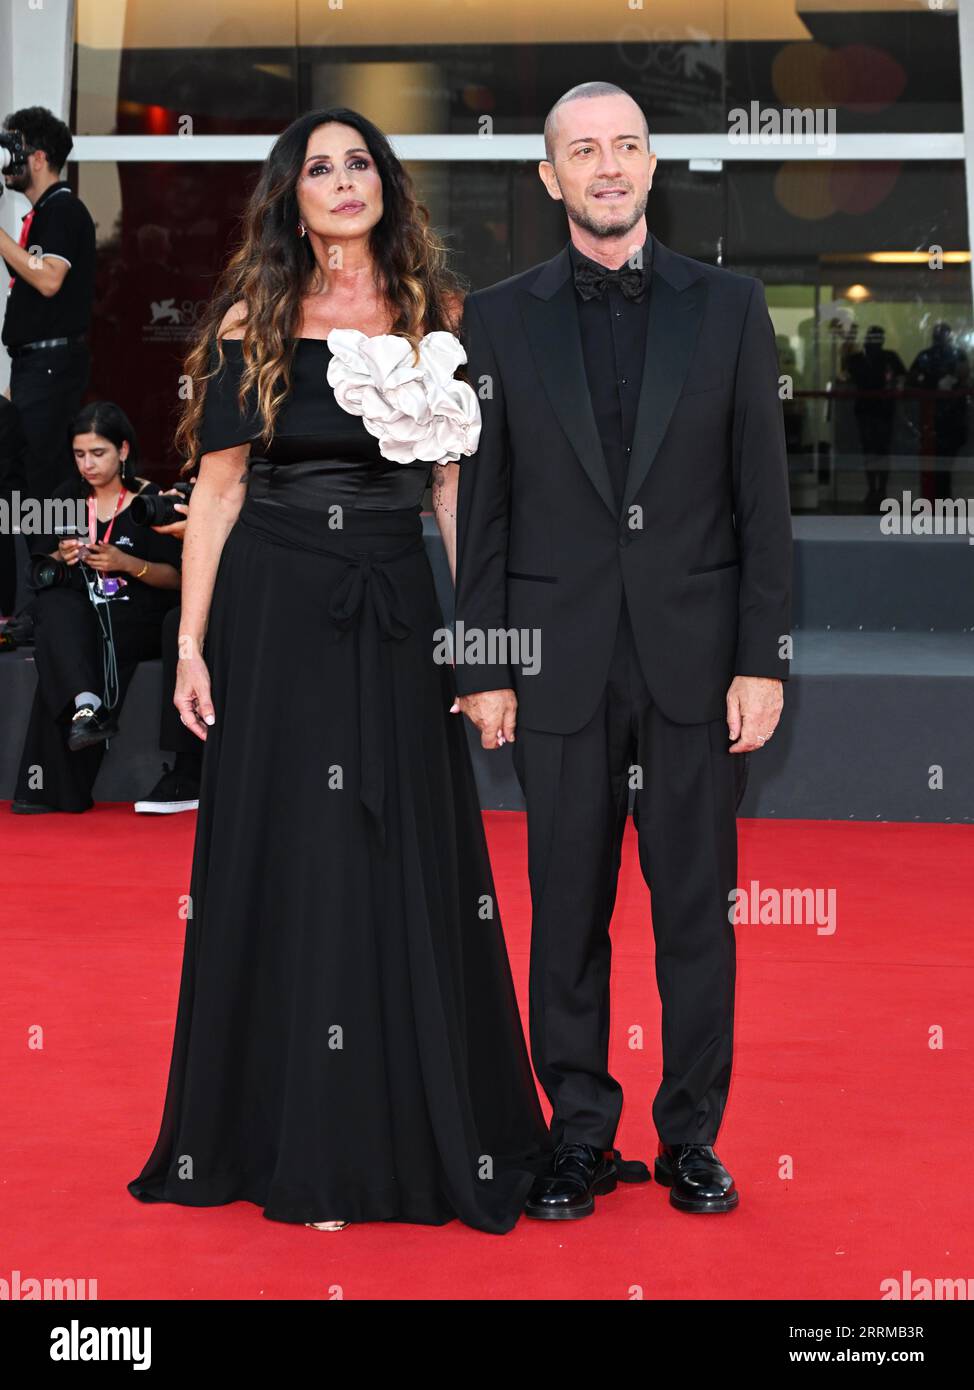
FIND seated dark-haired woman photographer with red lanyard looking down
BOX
[11,400,182,813]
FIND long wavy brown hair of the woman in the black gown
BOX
[175,107,464,474]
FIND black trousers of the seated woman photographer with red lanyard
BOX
[14,587,163,812]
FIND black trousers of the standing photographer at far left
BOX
[10,342,92,499]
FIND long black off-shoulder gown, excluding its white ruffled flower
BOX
[128,339,549,1232]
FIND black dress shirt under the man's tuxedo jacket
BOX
[568,234,653,510]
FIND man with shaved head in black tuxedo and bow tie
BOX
[454,83,792,1219]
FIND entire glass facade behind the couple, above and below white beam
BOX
[71,0,974,513]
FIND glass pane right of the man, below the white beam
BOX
[723,160,974,513]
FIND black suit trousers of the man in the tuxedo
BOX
[513,599,748,1148]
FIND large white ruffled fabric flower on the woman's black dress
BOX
[328,328,481,463]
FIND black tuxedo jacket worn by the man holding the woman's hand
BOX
[454,240,792,734]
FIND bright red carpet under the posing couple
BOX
[0,805,974,1300]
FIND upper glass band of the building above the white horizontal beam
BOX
[72,0,961,135]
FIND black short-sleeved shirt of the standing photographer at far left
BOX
[0,182,94,348]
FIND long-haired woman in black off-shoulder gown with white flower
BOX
[128,108,547,1232]
